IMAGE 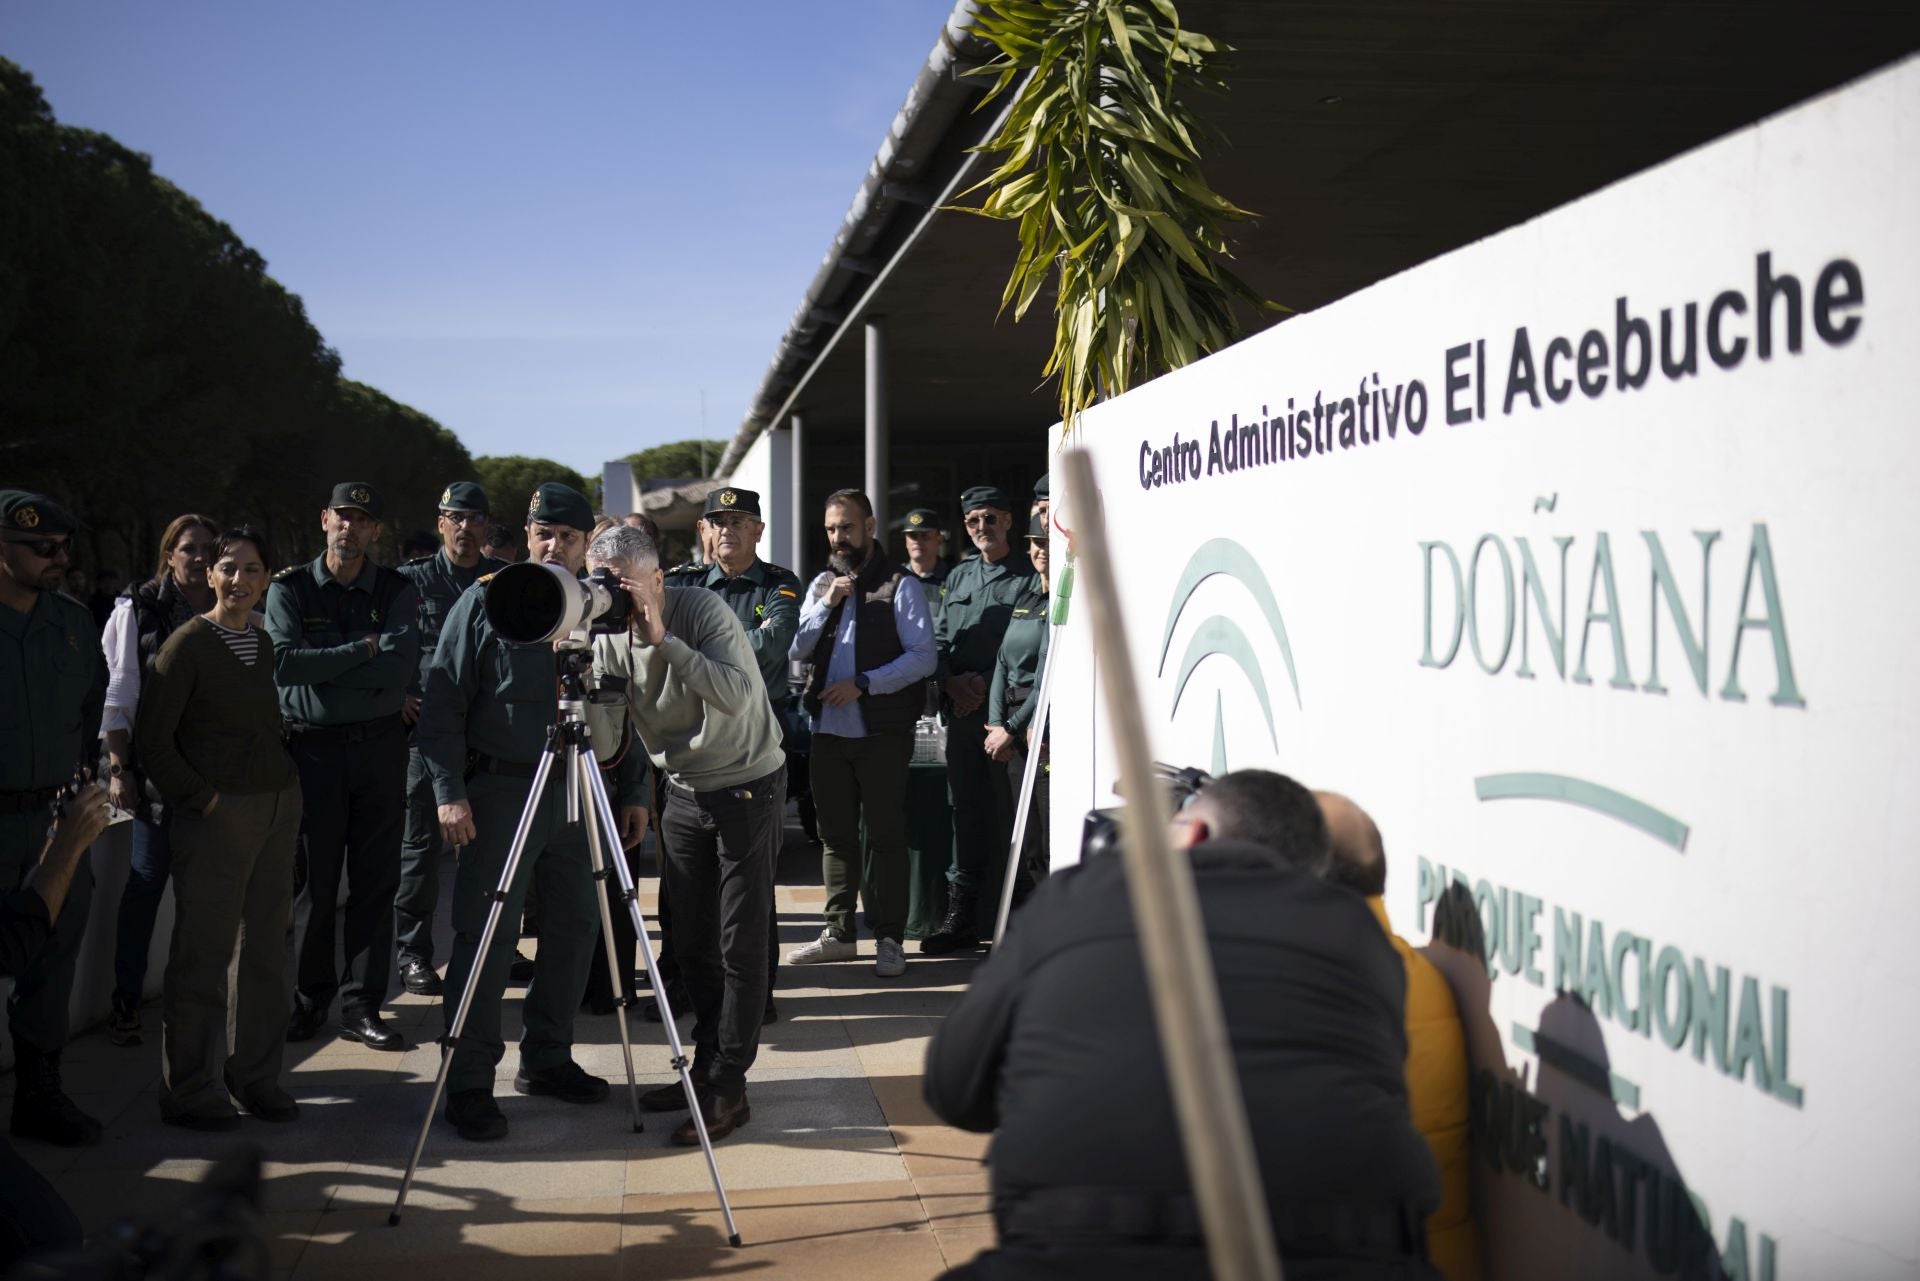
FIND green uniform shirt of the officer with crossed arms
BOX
[267,555,420,726]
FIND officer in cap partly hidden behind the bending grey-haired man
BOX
[670,486,801,1022]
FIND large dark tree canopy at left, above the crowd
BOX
[0,60,474,576]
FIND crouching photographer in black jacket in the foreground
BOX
[925,770,1440,1281]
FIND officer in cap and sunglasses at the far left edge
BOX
[0,490,108,1147]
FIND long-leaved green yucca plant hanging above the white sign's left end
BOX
[956,0,1275,432]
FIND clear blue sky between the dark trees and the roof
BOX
[0,0,952,472]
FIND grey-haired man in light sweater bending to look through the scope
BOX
[588,526,787,1147]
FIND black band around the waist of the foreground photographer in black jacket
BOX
[995,1187,1427,1258]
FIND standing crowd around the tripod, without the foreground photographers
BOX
[0,468,1046,1145]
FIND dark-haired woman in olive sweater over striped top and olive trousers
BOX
[134,526,300,1129]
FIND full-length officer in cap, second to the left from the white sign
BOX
[920,484,1033,956]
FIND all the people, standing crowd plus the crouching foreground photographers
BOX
[0,480,1478,1279]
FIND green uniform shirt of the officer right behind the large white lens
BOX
[413,578,651,805]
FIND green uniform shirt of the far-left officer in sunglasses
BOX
[0,592,108,791]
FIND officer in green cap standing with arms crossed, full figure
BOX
[267,480,420,1051]
